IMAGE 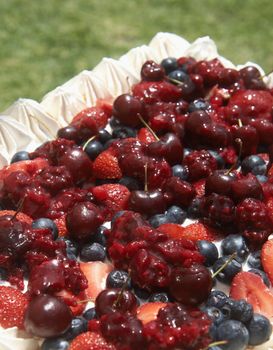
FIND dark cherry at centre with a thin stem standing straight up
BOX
[129,190,166,216]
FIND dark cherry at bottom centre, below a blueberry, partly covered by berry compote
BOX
[95,288,137,317]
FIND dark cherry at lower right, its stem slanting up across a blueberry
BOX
[169,264,213,305]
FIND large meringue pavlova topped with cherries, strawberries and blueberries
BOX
[0,33,273,350]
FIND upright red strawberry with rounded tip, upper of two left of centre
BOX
[93,150,122,179]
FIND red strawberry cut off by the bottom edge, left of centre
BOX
[68,332,116,350]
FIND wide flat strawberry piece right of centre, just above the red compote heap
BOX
[158,222,219,241]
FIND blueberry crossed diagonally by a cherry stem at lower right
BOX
[213,256,242,283]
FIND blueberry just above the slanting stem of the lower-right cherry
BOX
[221,234,249,262]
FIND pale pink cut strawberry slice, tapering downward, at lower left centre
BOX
[80,261,113,301]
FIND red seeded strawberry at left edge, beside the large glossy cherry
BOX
[0,286,28,329]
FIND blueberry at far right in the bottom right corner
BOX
[247,314,272,345]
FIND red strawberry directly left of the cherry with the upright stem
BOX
[91,184,130,214]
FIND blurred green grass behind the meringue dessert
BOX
[0,0,273,110]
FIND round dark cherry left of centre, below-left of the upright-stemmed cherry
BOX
[66,202,104,240]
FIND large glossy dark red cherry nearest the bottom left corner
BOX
[24,294,72,338]
